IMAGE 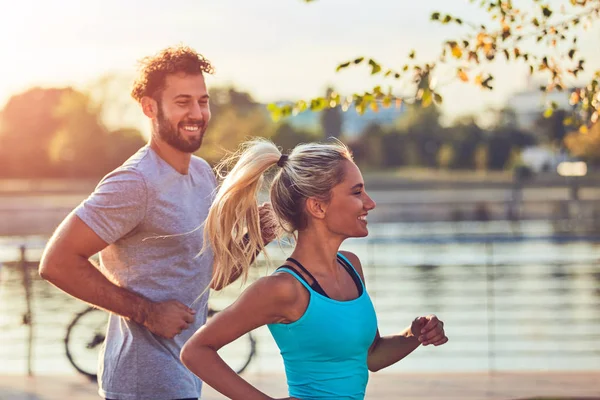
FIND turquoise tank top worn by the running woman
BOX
[267,253,377,400]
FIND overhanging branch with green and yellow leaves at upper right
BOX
[271,0,600,136]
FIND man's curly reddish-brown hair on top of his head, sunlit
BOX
[131,45,215,102]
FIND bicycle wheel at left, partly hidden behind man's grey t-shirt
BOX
[65,307,108,381]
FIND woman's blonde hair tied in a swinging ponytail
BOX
[204,138,352,288]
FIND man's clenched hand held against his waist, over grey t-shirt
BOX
[142,300,196,339]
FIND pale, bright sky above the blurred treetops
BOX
[0,0,600,131]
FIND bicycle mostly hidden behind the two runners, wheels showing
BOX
[64,306,256,381]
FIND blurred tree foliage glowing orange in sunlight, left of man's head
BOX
[0,88,145,178]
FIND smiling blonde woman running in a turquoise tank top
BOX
[181,140,448,400]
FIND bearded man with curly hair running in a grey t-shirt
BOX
[40,46,270,400]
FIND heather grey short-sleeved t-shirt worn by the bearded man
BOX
[75,146,216,400]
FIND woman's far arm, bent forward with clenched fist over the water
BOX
[341,251,448,371]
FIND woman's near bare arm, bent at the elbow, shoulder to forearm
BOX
[181,274,298,400]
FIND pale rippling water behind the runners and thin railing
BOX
[0,222,600,373]
